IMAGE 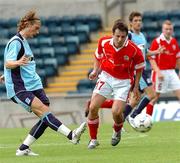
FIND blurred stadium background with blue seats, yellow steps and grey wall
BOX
[0,0,180,128]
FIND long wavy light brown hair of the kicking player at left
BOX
[17,10,41,32]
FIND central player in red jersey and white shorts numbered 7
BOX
[87,19,144,149]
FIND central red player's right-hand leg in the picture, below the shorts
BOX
[111,100,126,146]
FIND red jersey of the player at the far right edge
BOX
[149,34,180,70]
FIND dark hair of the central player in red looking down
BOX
[112,19,128,34]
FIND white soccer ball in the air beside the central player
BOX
[134,113,152,132]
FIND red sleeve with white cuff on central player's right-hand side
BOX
[134,48,145,70]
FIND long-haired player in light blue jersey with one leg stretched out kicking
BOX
[4,11,86,156]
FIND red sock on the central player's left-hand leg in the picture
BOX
[88,117,99,139]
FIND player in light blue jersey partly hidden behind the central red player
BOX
[124,11,164,127]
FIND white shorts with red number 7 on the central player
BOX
[93,71,131,101]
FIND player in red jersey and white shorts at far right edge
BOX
[147,20,180,114]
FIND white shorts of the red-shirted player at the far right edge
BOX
[152,70,180,93]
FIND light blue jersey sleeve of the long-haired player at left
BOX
[4,40,21,61]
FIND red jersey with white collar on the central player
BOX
[95,36,145,79]
